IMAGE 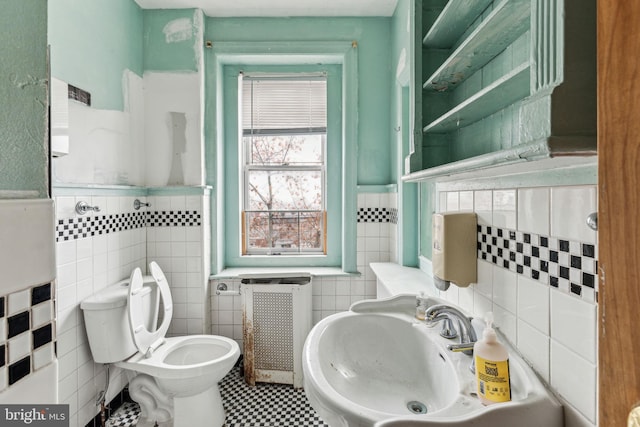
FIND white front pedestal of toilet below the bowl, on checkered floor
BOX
[173,384,225,427]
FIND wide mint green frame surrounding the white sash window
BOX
[210,41,359,273]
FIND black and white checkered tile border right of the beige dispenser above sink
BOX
[478,225,598,302]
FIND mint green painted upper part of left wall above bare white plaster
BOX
[47,0,143,111]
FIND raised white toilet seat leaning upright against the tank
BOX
[127,262,173,357]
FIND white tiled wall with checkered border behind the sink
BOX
[437,184,598,427]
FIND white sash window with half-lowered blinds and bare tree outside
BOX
[239,74,327,255]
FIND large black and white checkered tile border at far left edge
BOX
[0,283,56,391]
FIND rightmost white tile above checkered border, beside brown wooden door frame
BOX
[551,186,597,243]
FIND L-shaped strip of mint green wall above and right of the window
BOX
[205,18,394,185]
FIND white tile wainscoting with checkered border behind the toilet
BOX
[55,188,210,426]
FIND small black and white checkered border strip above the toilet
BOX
[56,211,202,242]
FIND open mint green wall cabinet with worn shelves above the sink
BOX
[403,0,596,181]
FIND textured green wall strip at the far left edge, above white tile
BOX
[0,0,48,198]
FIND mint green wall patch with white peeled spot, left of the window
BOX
[143,9,202,71]
